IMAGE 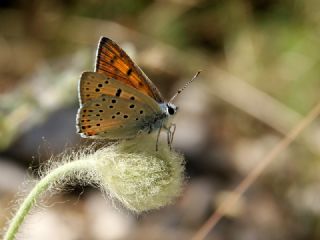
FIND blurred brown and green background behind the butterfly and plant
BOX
[0,0,320,240]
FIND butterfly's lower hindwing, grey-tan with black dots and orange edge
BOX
[77,96,159,139]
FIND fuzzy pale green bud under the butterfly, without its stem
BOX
[96,137,184,213]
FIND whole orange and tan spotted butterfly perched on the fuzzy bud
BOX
[76,37,199,147]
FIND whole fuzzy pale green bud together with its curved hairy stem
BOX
[4,136,184,240]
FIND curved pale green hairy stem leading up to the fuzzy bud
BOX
[4,160,95,240]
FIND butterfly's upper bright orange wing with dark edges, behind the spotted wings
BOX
[96,37,164,103]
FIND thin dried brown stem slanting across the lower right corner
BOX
[192,102,320,240]
